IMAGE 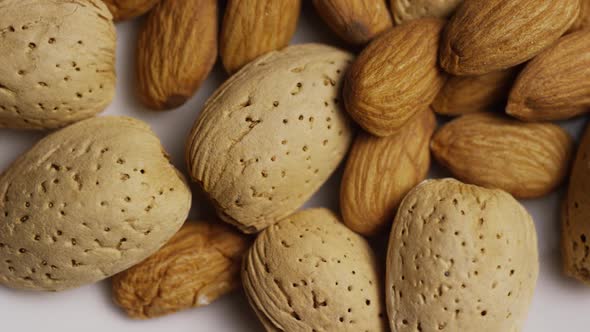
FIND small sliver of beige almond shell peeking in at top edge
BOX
[391,0,463,24]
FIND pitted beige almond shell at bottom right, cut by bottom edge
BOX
[385,179,539,332]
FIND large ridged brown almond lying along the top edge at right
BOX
[440,0,580,75]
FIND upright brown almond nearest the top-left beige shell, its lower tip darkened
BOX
[136,0,217,110]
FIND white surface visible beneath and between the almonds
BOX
[0,6,590,332]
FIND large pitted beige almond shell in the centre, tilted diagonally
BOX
[186,44,352,233]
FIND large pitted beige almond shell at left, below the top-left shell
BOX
[0,117,191,291]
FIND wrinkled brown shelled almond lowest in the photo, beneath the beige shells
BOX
[112,221,250,319]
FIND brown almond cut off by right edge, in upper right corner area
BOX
[506,29,590,121]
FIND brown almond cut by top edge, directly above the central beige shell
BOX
[224,0,301,74]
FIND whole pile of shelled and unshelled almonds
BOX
[0,0,590,332]
